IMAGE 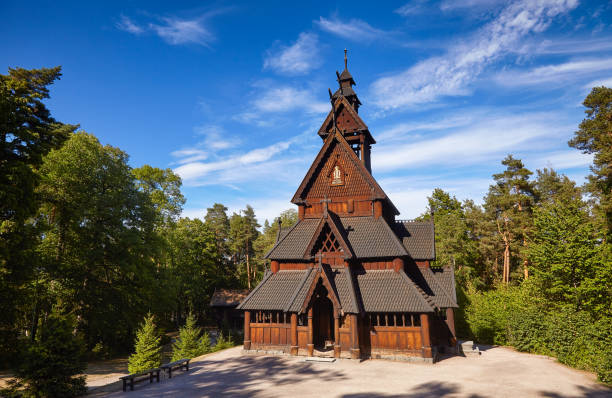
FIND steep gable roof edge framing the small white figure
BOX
[291,133,399,214]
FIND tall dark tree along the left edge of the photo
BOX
[0,67,76,366]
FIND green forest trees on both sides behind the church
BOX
[0,68,612,392]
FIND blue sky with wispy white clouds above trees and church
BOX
[0,0,612,223]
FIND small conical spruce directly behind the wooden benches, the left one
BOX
[128,313,162,373]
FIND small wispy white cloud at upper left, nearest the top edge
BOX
[149,17,215,46]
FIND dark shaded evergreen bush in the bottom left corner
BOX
[3,313,86,398]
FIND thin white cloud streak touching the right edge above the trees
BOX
[494,58,612,86]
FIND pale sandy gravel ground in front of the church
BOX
[95,347,612,398]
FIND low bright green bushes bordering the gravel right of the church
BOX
[460,283,612,384]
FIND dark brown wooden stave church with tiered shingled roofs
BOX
[238,55,457,361]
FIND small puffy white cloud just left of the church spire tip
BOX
[264,32,321,75]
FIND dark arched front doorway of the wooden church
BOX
[312,281,334,350]
